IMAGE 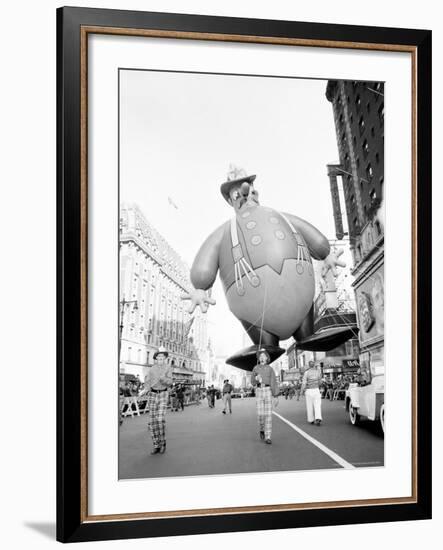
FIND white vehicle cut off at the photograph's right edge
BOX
[345,366,385,434]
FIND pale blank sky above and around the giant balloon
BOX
[120,70,338,355]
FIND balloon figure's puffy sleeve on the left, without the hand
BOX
[191,223,226,290]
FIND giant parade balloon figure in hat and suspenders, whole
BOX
[182,166,355,371]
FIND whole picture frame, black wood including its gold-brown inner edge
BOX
[57,8,432,542]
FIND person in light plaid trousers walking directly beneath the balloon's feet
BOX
[251,348,279,445]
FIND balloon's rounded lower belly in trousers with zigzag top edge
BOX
[226,259,315,340]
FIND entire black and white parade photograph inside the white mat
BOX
[115,68,389,480]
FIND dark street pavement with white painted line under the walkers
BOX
[119,396,384,479]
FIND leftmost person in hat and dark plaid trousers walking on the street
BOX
[143,347,172,455]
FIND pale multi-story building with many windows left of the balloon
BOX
[120,205,210,383]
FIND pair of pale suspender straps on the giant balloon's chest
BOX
[231,212,312,296]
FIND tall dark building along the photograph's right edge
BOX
[326,80,384,376]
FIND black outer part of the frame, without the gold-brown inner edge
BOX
[57,8,432,542]
